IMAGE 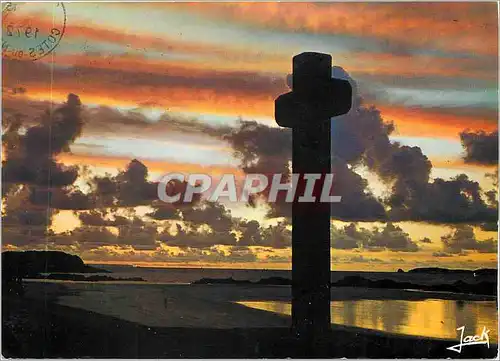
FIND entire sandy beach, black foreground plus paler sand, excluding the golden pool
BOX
[3,282,497,357]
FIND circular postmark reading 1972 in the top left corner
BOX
[2,2,66,60]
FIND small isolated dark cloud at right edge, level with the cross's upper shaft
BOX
[460,130,498,165]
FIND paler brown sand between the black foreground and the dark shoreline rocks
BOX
[23,282,496,335]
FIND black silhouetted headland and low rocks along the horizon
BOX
[2,251,497,296]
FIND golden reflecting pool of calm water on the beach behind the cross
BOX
[238,299,498,343]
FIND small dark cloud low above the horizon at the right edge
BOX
[441,225,498,254]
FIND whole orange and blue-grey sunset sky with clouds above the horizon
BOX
[2,2,498,271]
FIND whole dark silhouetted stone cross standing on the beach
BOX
[275,52,352,356]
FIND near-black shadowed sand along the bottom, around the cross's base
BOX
[2,285,497,358]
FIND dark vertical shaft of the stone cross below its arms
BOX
[292,122,331,352]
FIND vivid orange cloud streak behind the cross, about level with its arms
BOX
[7,83,497,138]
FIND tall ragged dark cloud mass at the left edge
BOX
[2,94,102,250]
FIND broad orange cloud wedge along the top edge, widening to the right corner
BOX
[172,2,498,56]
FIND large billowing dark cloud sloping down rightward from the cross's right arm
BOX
[332,69,498,223]
